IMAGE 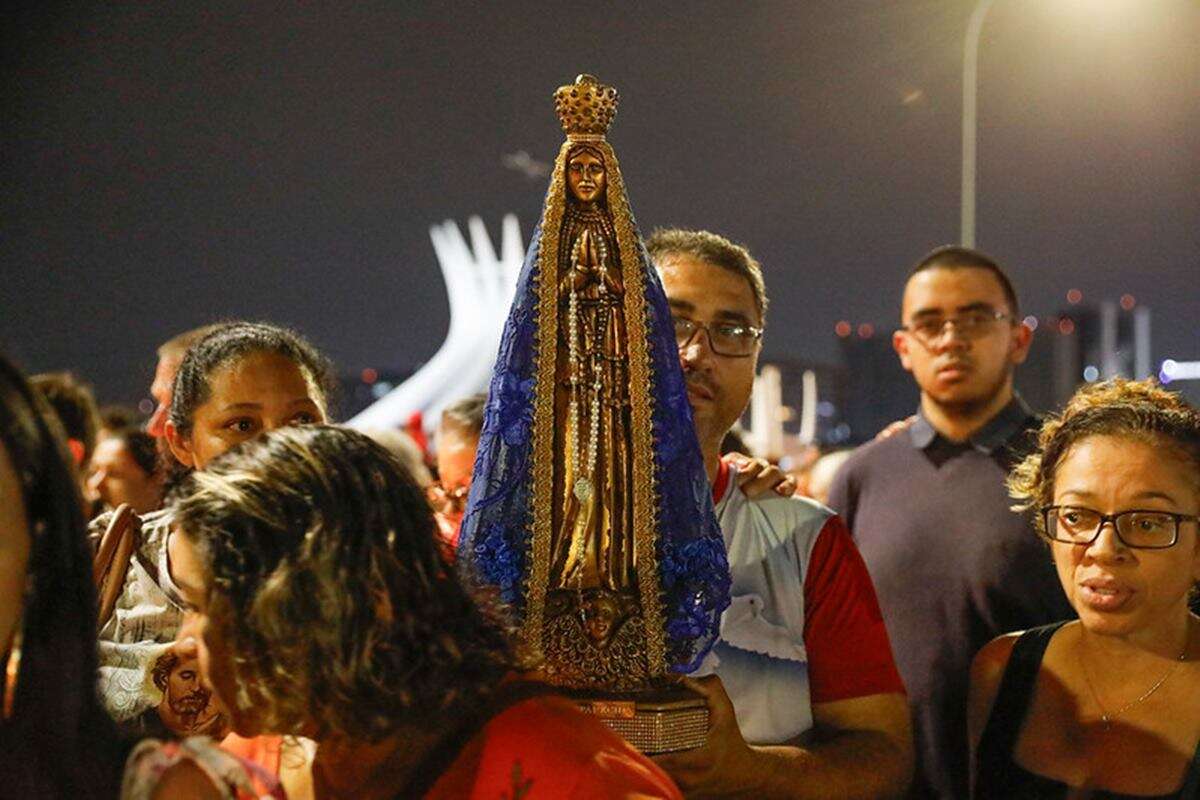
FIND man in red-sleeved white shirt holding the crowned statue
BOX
[647,230,912,798]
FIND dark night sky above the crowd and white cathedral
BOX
[0,0,1200,410]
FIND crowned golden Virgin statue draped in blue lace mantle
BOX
[460,76,730,752]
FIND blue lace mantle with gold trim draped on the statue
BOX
[458,144,730,673]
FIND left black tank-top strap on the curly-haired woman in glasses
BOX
[976,621,1066,798]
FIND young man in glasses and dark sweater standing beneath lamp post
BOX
[829,247,1074,798]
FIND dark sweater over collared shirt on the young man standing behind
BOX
[829,396,1073,798]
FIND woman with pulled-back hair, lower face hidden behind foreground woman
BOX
[92,321,334,736]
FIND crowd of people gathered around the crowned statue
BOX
[0,229,1200,800]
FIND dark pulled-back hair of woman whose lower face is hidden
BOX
[170,321,337,434]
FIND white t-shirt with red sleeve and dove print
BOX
[702,462,904,744]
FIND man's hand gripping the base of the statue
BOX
[654,675,755,798]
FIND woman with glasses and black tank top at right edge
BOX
[968,380,1200,798]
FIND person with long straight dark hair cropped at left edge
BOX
[0,357,127,799]
